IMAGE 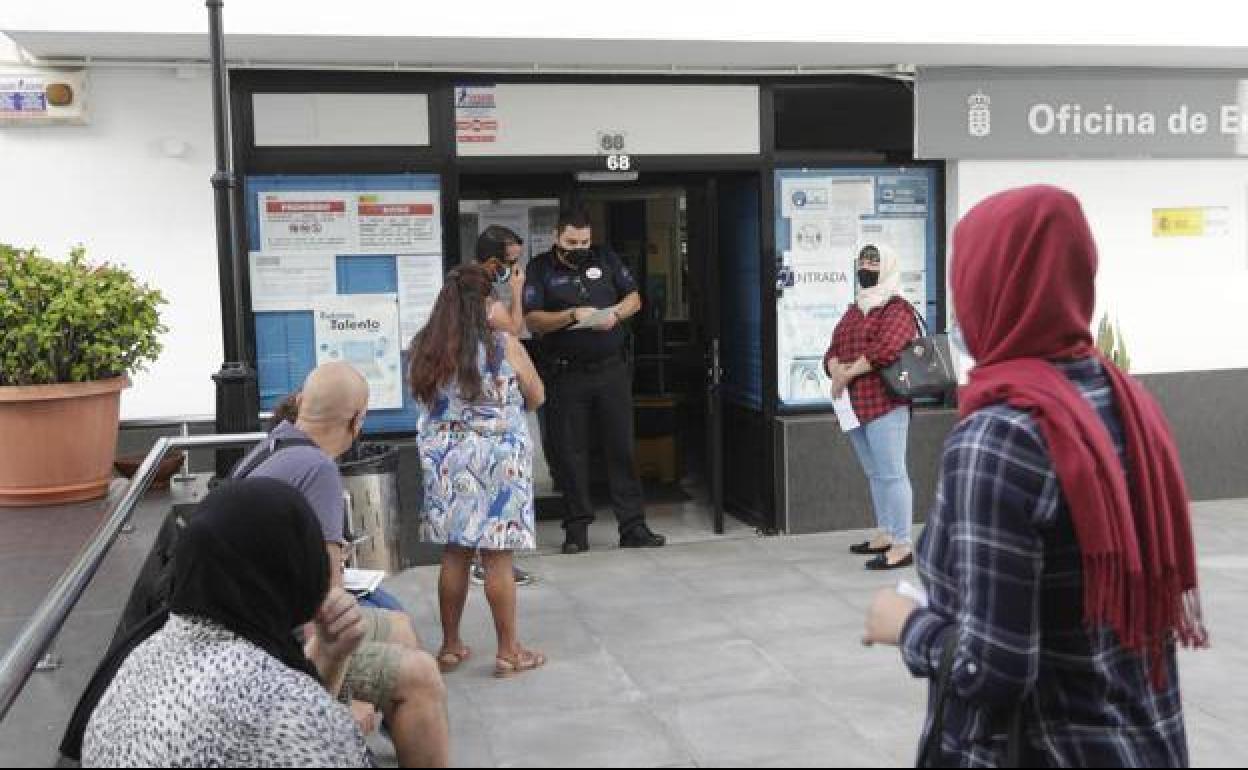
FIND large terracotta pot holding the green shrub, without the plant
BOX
[0,377,130,508]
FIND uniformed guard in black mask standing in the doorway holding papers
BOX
[524,208,666,554]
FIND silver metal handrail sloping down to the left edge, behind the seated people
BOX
[0,433,266,723]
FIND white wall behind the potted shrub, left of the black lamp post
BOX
[0,53,222,418]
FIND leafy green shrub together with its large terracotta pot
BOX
[0,243,167,507]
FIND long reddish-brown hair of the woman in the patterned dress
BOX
[408,265,500,407]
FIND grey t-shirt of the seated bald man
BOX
[242,422,347,545]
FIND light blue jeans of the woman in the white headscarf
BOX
[849,407,915,545]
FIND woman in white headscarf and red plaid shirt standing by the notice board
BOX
[824,243,919,570]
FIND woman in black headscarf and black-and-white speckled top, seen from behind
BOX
[80,479,368,768]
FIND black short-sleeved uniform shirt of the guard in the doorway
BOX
[524,248,638,363]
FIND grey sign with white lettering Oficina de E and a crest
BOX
[915,69,1248,158]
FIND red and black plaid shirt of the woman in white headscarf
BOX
[824,297,919,424]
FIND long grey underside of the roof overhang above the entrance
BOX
[4,30,1248,74]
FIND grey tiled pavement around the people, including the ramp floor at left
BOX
[0,495,1248,766]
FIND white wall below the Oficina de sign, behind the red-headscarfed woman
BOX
[951,160,1248,373]
